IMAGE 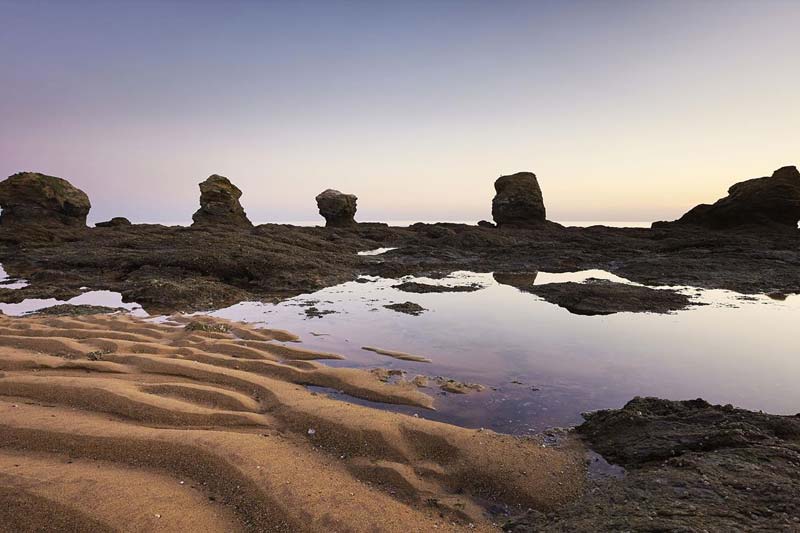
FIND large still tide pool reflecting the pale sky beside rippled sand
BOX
[213,271,800,433]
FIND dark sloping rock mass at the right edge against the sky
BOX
[676,167,800,228]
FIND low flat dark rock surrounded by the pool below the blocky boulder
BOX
[524,279,692,315]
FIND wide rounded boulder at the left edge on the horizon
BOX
[0,172,92,226]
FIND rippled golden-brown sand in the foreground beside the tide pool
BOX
[0,315,584,533]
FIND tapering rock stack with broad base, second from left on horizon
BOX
[192,174,253,228]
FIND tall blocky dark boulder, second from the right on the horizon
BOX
[492,172,546,227]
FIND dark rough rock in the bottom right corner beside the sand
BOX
[505,398,800,533]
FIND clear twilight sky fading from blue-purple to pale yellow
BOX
[0,0,800,222]
